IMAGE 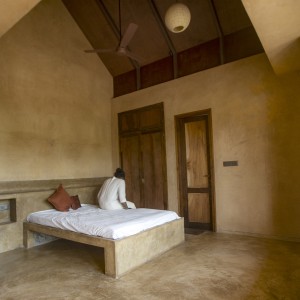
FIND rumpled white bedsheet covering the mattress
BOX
[27,204,179,239]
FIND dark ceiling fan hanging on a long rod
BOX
[84,0,140,62]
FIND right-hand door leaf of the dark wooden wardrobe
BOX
[141,132,166,209]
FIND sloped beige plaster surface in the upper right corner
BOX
[242,0,300,74]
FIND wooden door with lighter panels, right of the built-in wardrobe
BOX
[176,112,214,230]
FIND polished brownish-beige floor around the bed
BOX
[0,232,300,300]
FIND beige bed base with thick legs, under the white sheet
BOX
[23,218,184,278]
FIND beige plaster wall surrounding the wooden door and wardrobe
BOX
[112,54,300,239]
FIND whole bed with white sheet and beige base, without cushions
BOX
[24,205,184,278]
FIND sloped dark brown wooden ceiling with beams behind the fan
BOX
[62,0,263,97]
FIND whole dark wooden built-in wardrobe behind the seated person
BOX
[119,103,167,209]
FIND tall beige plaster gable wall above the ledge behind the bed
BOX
[0,0,113,181]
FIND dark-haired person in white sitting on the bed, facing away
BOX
[97,168,136,210]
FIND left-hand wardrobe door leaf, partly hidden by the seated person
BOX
[120,135,144,207]
